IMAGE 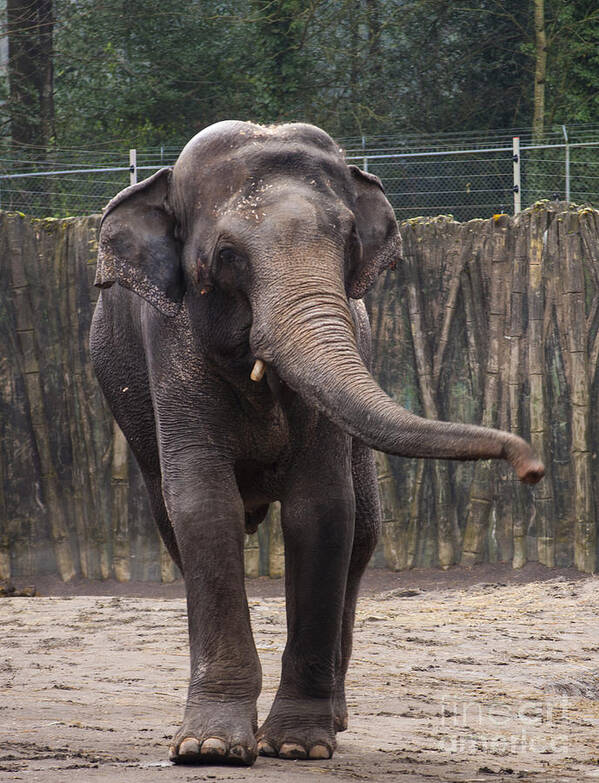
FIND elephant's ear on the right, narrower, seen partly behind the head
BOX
[347,165,401,299]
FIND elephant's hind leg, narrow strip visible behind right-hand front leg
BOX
[334,440,381,731]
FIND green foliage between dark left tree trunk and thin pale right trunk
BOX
[47,0,544,146]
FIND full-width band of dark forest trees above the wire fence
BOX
[0,0,599,154]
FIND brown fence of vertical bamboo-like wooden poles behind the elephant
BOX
[0,202,599,581]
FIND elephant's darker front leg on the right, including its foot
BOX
[258,444,354,759]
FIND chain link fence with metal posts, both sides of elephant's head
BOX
[0,125,599,221]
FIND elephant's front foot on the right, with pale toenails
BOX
[257,697,336,760]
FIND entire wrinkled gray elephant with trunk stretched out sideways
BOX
[91,122,543,764]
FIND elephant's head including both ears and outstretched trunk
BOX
[96,122,543,483]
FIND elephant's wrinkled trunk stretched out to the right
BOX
[252,275,544,484]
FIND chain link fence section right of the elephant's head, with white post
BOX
[346,125,599,221]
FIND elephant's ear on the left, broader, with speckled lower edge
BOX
[95,168,185,316]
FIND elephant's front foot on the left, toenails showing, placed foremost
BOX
[169,702,258,767]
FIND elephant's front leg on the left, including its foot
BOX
[164,466,261,765]
